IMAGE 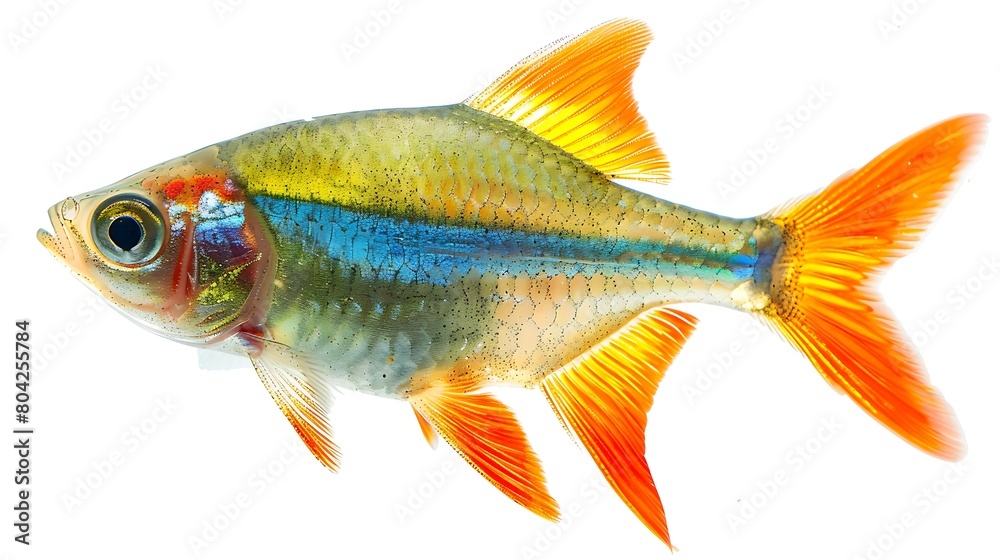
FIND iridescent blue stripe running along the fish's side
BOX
[250,196,757,285]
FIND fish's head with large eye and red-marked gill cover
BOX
[38,146,274,346]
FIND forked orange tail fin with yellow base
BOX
[762,115,987,461]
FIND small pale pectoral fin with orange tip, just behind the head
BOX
[251,353,340,472]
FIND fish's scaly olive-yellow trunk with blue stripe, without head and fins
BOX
[217,105,767,398]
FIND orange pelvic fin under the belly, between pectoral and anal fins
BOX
[408,377,559,521]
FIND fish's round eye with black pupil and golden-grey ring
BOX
[91,195,164,267]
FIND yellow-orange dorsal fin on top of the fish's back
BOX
[465,19,670,183]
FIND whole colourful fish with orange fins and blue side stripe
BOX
[37,19,988,550]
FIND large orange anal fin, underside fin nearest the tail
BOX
[542,307,696,548]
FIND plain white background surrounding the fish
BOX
[0,0,1000,559]
